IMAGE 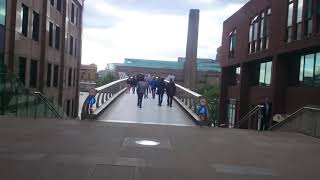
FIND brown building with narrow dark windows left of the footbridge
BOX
[0,0,84,116]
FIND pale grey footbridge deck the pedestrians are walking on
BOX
[98,91,195,126]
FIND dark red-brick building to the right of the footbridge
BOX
[219,0,320,127]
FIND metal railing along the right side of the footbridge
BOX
[166,80,209,124]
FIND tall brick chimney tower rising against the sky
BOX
[184,9,200,90]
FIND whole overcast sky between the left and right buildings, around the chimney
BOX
[82,0,248,70]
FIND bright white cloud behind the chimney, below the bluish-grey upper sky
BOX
[82,0,245,69]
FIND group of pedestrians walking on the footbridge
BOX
[126,74,176,108]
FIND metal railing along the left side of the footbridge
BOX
[80,79,127,119]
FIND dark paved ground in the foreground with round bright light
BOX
[0,117,320,180]
